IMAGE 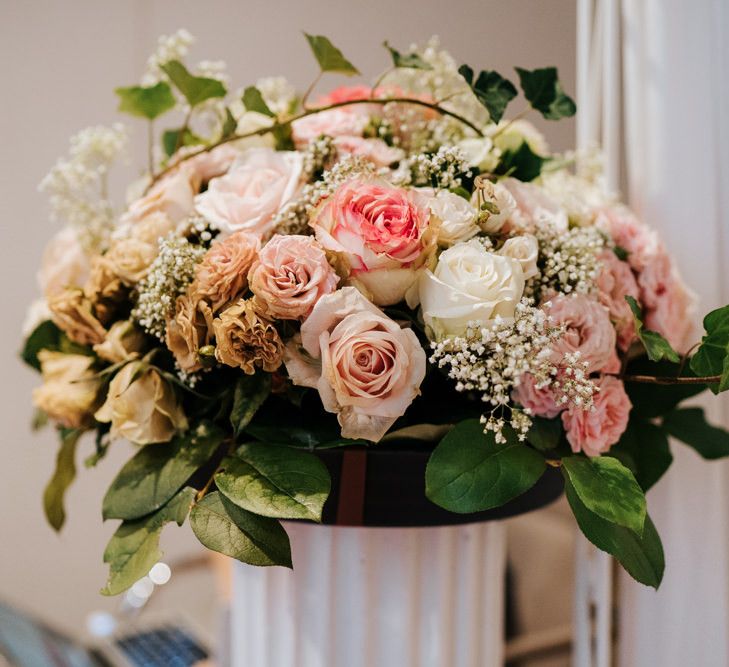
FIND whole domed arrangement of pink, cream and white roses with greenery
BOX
[22,31,729,594]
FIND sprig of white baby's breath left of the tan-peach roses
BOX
[132,233,206,340]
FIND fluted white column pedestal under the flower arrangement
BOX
[231,522,506,667]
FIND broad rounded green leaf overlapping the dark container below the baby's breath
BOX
[425,419,546,514]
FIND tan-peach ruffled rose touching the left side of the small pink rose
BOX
[191,232,261,313]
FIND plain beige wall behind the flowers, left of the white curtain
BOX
[0,0,575,640]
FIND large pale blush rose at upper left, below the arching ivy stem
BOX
[195,148,303,238]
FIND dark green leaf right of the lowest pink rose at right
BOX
[610,414,673,491]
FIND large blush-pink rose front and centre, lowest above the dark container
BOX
[284,287,425,442]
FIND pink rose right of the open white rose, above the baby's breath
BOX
[547,294,616,372]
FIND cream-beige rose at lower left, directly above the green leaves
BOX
[95,361,187,445]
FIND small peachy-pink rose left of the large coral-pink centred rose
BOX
[248,234,339,320]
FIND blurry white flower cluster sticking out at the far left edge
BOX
[39,123,127,252]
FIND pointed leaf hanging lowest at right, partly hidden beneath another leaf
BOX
[565,478,665,589]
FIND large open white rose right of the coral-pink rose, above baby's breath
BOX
[418,239,524,339]
